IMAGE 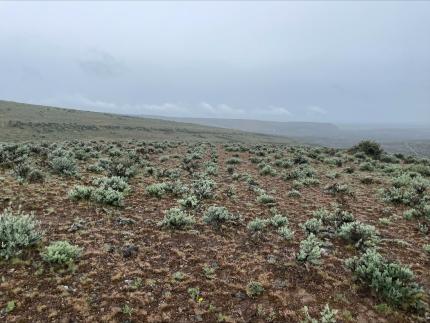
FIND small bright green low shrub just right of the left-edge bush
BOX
[41,241,82,264]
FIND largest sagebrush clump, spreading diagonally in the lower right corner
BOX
[346,249,424,310]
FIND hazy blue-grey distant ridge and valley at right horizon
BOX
[155,116,430,156]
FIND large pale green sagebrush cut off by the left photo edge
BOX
[0,208,42,259]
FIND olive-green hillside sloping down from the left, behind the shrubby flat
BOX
[0,101,291,143]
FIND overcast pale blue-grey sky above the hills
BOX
[0,1,430,123]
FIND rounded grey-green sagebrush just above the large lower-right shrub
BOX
[338,221,378,249]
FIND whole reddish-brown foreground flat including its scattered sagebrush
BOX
[0,141,430,322]
